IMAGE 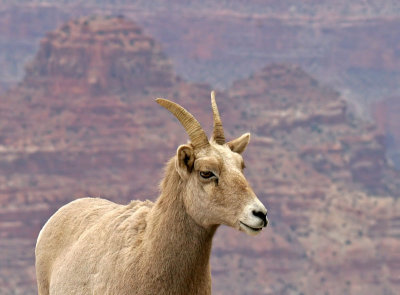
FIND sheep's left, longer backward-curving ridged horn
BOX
[156,98,209,149]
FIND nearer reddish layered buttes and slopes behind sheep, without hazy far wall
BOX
[0,17,400,295]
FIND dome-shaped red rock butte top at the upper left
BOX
[25,17,175,95]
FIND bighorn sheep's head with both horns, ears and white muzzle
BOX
[157,92,268,235]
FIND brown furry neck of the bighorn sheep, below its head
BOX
[138,164,217,294]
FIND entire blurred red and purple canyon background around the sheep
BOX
[0,0,400,295]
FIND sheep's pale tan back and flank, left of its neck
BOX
[36,198,153,294]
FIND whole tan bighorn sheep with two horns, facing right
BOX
[35,92,268,295]
